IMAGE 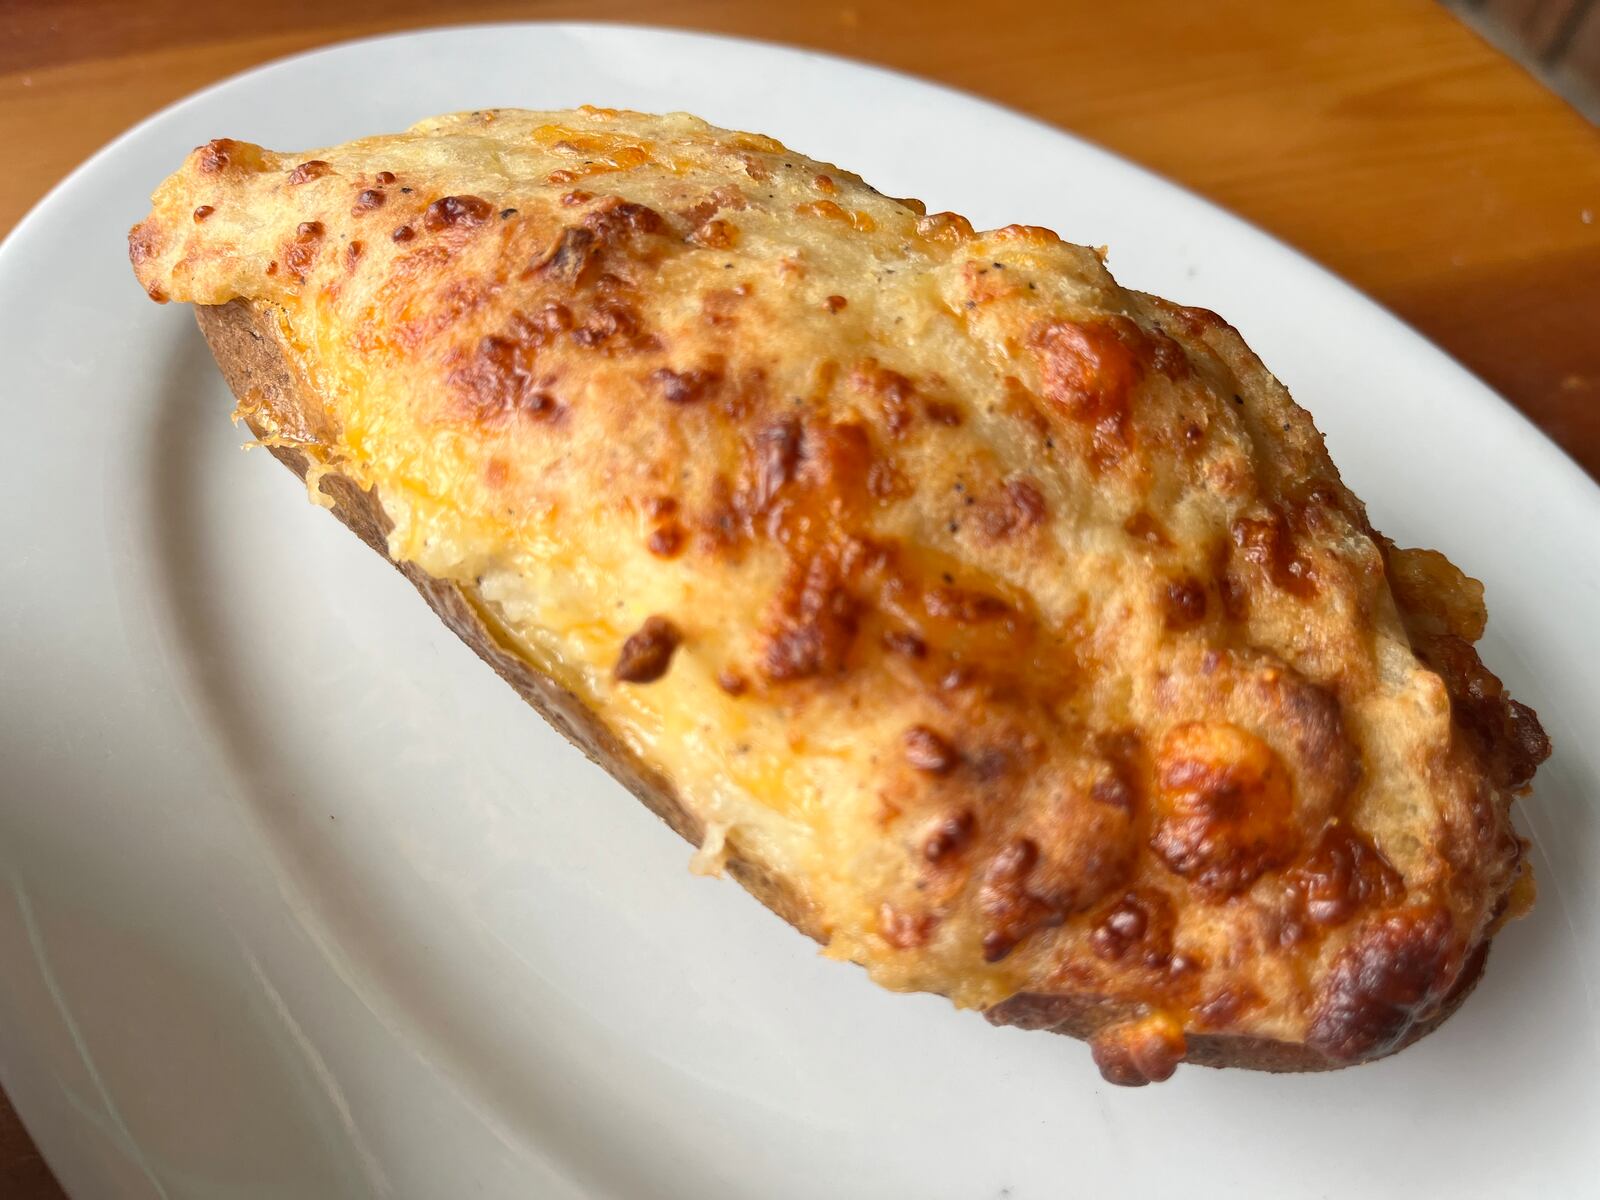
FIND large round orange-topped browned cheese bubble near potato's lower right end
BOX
[1150,722,1298,894]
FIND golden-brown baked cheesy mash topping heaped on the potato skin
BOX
[130,109,1549,1083]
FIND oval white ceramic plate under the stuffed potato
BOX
[0,26,1600,1200]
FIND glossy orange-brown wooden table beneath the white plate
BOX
[0,0,1600,1200]
